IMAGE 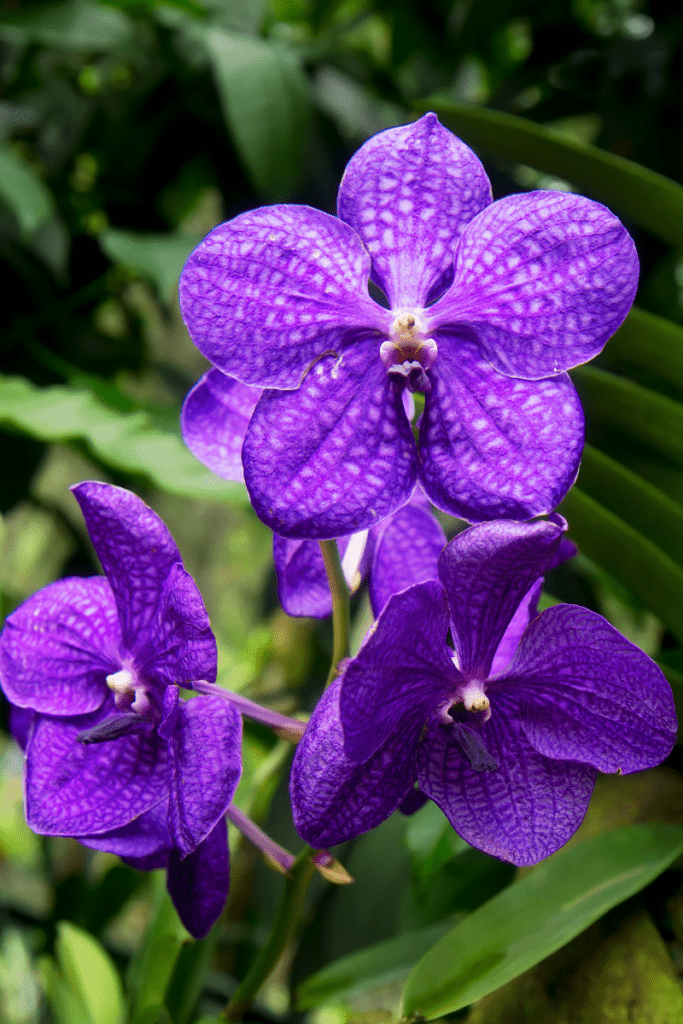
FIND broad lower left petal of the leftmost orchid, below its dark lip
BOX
[26,697,169,838]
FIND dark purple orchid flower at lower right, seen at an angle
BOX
[291,517,676,864]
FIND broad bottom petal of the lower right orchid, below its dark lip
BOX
[416,694,596,865]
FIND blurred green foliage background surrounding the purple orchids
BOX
[0,0,683,1024]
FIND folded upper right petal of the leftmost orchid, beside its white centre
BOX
[141,564,217,686]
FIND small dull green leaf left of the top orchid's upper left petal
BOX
[97,227,202,299]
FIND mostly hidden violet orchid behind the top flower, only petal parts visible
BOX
[180,370,446,618]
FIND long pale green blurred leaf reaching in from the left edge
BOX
[0,376,248,505]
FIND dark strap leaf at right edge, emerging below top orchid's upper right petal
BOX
[604,306,683,390]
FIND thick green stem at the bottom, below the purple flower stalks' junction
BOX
[223,846,315,1021]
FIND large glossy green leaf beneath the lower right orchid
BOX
[402,824,683,1020]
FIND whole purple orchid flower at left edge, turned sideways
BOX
[0,481,242,937]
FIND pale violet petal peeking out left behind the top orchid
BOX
[180,370,261,480]
